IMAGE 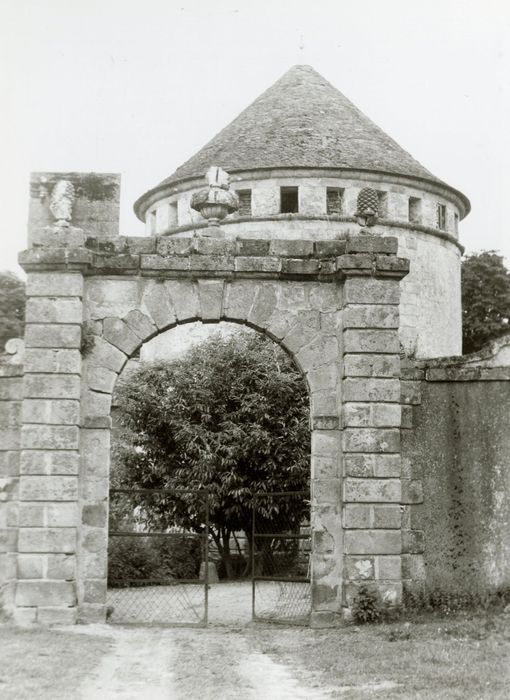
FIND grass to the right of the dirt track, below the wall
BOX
[258,613,510,700]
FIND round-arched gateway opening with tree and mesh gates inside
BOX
[108,322,311,624]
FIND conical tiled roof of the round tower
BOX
[159,65,444,187]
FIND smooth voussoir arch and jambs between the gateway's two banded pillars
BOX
[78,278,342,614]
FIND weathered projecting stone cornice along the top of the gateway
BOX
[19,234,409,281]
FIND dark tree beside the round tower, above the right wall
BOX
[462,250,510,353]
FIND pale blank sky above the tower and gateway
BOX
[0,0,510,271]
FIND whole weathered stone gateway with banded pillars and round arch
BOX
[2,174,408,625]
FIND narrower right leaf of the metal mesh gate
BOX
[251,491,311,624]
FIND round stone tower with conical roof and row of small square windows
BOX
[134,66,470,358]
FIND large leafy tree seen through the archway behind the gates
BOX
[113,333,310,577]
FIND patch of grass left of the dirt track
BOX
[0,624,111,700]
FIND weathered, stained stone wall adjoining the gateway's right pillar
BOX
[402,341,510,594]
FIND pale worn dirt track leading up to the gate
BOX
[78,625,331,700]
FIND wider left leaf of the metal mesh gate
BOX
[107,488,209,626]
